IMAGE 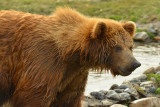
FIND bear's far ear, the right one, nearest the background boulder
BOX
[122,21,136,37]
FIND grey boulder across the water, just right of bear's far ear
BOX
[134,32,150,42]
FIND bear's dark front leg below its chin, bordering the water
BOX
[50,71,88,107]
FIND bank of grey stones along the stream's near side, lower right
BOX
[82,66,160,107]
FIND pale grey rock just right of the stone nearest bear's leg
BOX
[106,90,120,101]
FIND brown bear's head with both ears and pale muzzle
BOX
[81,20,141,76]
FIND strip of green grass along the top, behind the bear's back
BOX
[0,0,160,23]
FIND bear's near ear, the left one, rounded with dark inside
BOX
[91,22,107,39]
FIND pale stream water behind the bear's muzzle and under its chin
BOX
[85,43,160,95]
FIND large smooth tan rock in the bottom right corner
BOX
[129,97,160,107]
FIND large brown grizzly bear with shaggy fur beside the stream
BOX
[0,8,141,107]
